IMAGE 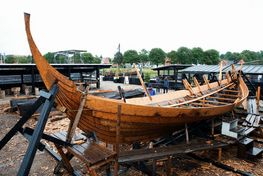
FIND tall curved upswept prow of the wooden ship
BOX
[24,13,75,90]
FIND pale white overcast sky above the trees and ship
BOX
[0,0,263,57]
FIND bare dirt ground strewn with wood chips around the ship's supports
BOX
[0,95,263,176]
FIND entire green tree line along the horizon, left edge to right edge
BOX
[5,47,263,66]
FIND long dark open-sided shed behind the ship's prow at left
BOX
[0,64,111,91]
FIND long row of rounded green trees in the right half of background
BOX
[113,47,263,66]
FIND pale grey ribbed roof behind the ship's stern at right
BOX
[181,65,263,75]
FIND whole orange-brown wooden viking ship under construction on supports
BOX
[25,14,248,144]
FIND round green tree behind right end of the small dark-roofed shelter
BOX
[176,47,193,64]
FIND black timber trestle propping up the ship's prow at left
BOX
[0,84,70,176]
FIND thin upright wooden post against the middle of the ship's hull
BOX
[114,104,121,176]
